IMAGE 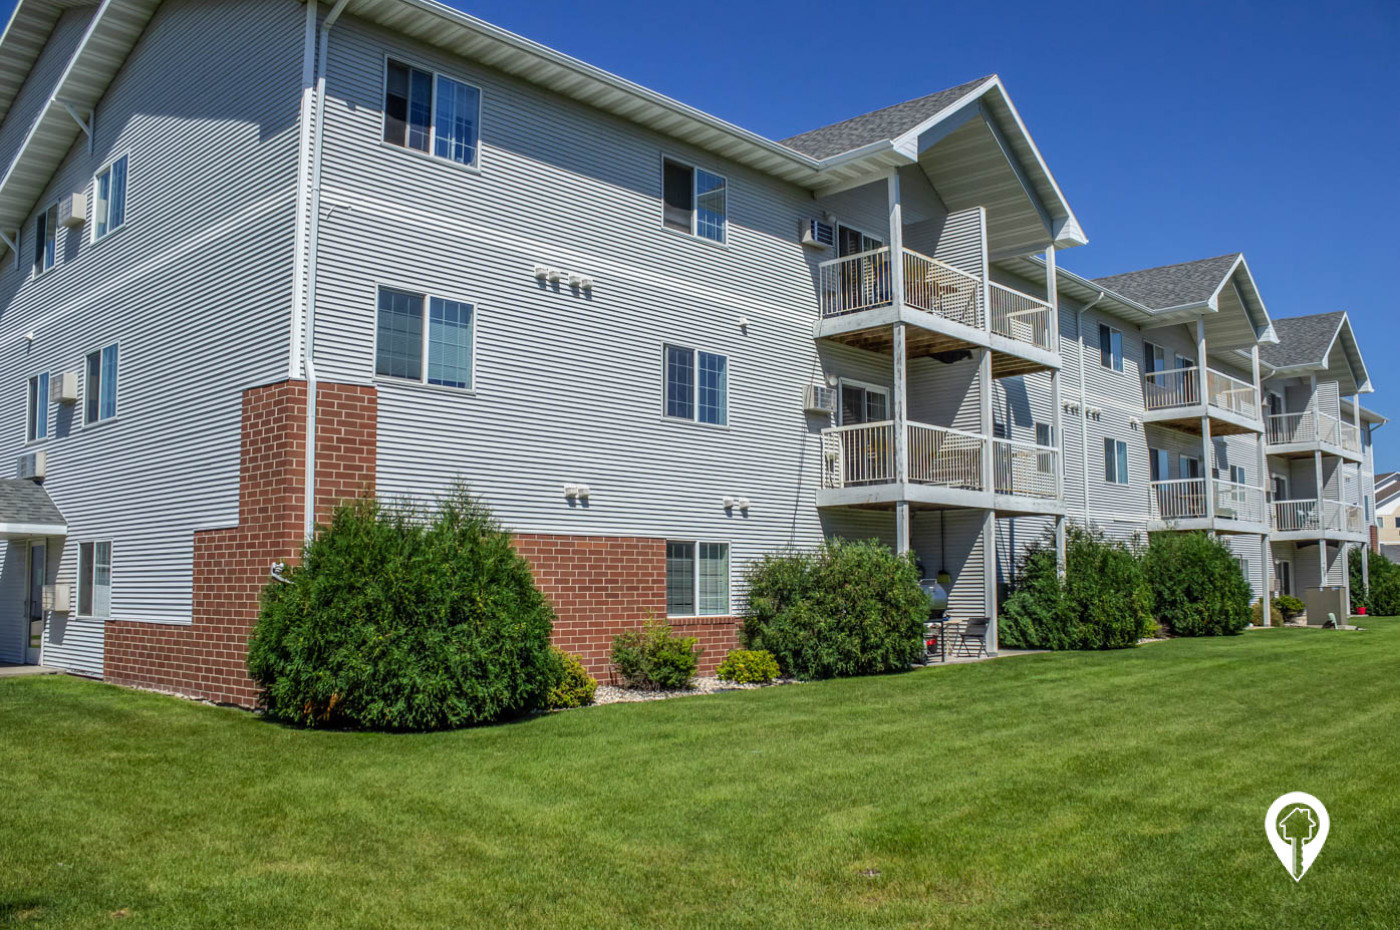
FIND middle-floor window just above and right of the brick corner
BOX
[374,287,476,391]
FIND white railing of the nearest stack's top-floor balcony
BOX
[819,247,1053,349]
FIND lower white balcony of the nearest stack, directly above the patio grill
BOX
[818,420,1063,513]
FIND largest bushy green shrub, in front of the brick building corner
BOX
[248,487,560,730]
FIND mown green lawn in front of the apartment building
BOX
[0,618,1400,930]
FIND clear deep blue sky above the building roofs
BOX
[0,0,1400,456]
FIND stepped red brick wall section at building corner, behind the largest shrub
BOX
[104,381,378,707]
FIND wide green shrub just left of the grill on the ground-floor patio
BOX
[743,539,928,679]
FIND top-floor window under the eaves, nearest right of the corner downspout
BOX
[384,59,482,168]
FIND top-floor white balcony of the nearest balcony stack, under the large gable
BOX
[816,247,1058,378]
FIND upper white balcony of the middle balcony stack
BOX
[1142,367,1264,436]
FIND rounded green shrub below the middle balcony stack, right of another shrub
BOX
[1142,532,1250,636]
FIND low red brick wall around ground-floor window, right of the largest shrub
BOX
[515,534,738,682]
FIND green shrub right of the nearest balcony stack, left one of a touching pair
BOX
[1000,524,1155,650]
